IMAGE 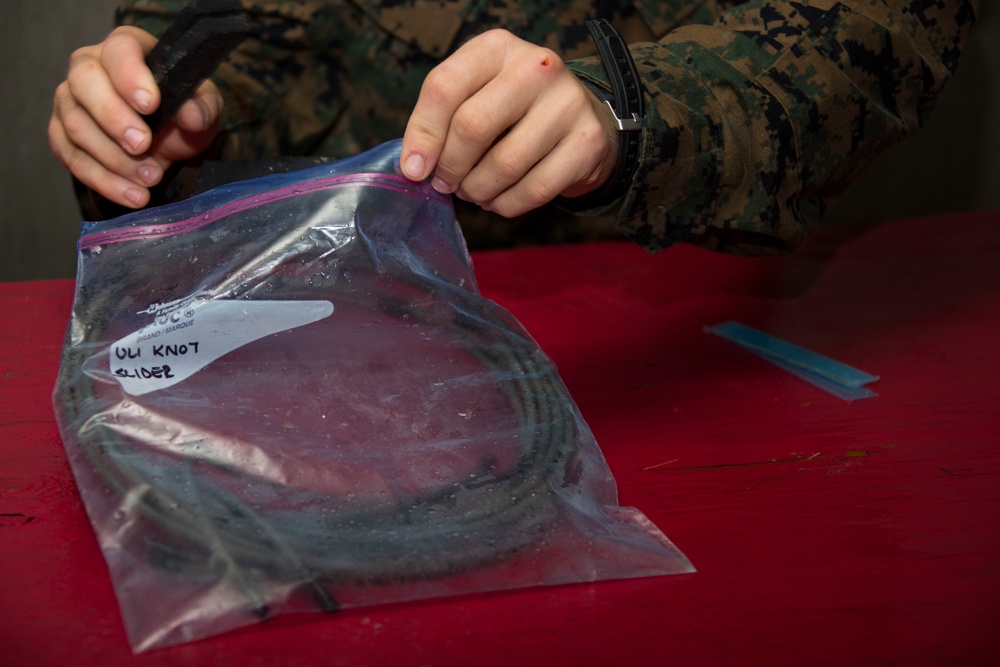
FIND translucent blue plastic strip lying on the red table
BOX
[705,321,879,401]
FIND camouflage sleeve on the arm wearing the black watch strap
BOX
[569,0,978,255]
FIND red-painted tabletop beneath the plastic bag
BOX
[0,212,1000,667]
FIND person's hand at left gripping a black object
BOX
[49,27,222,208]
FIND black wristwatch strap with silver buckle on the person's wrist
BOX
[560,19,644,211]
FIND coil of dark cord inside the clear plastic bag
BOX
[56,155,579,615]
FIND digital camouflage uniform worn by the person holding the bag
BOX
[109,0,978,254]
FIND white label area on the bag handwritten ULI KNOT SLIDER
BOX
[110,300,333,396]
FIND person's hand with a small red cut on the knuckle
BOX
[400,30,617,217]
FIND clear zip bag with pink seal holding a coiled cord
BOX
[54,142,693,652]
